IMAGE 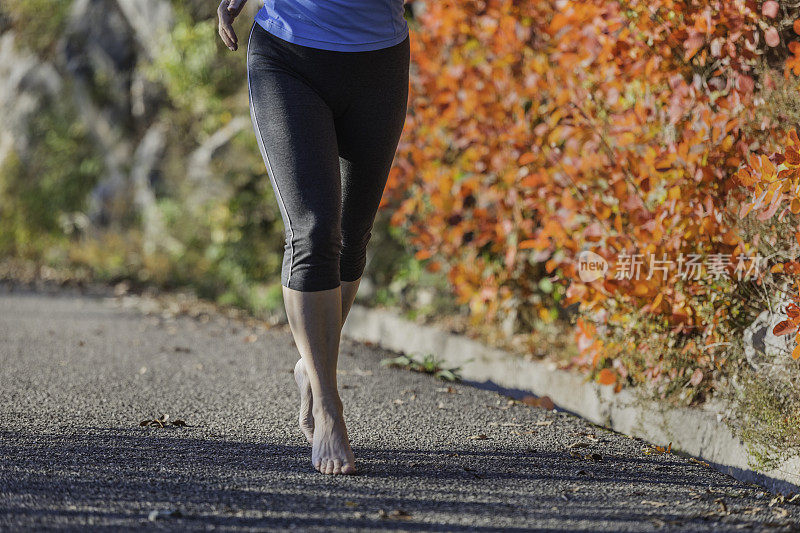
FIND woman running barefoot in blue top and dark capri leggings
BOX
[218,0,410,474]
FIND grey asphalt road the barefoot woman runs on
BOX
[0,289,800,531]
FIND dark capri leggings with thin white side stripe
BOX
[247,23,410,291]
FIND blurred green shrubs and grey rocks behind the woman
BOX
[0,0,448,320]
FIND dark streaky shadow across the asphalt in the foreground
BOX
[0,427,780,531]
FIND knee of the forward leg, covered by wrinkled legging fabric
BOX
[285,223,342,291]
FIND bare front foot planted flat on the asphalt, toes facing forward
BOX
[311,398,356,474]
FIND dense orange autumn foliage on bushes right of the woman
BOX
[384,0,800,383]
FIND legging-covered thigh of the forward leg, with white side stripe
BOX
[247,27,341,243]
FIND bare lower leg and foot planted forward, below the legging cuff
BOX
[283,287,355,474]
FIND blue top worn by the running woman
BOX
[256,0,408,52]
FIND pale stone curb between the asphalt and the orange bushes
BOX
[343,305,800,493]
